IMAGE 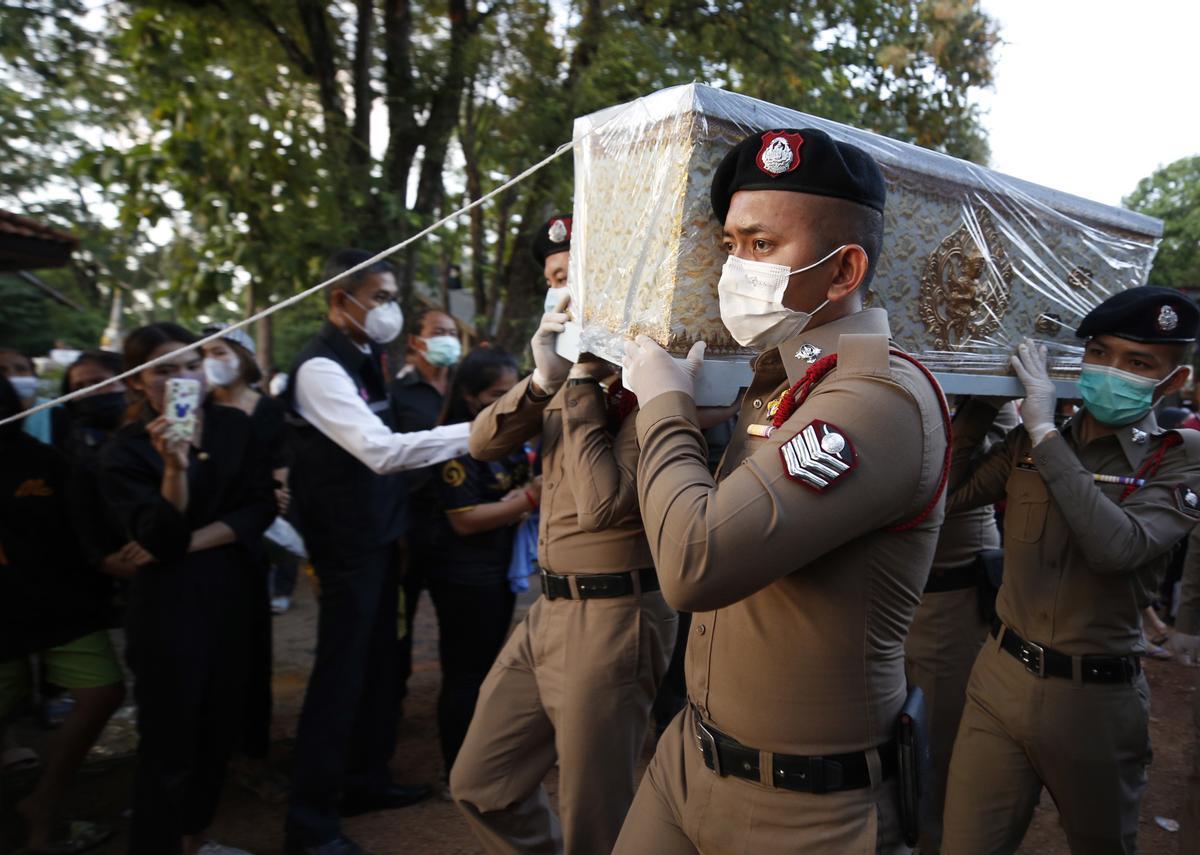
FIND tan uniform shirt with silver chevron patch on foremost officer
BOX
[637,309,946,754]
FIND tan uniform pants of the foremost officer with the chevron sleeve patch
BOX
[613,706,908,855]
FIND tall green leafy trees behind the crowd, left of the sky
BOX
[0,0,997,361]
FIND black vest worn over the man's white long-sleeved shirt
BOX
[282,321,408,561]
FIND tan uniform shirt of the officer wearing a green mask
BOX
[947,401,1200,656]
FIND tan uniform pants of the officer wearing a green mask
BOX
[942,636,1151,855]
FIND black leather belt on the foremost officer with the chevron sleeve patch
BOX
[691,707,896,795]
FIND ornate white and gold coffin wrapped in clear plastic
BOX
[570,84,1162,397]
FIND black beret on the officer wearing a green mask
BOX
[1075,285,1200,345]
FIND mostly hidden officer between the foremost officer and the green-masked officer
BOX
[905,403,1018,855]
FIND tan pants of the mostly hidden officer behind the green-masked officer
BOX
[905,587,988,855]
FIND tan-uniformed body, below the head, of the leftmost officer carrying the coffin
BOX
[450,214,678,854]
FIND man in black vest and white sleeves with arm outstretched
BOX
[283,250,469,855]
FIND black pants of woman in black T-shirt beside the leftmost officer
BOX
[430,579,516,778]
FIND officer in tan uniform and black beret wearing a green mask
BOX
[942,287,1200,855]
